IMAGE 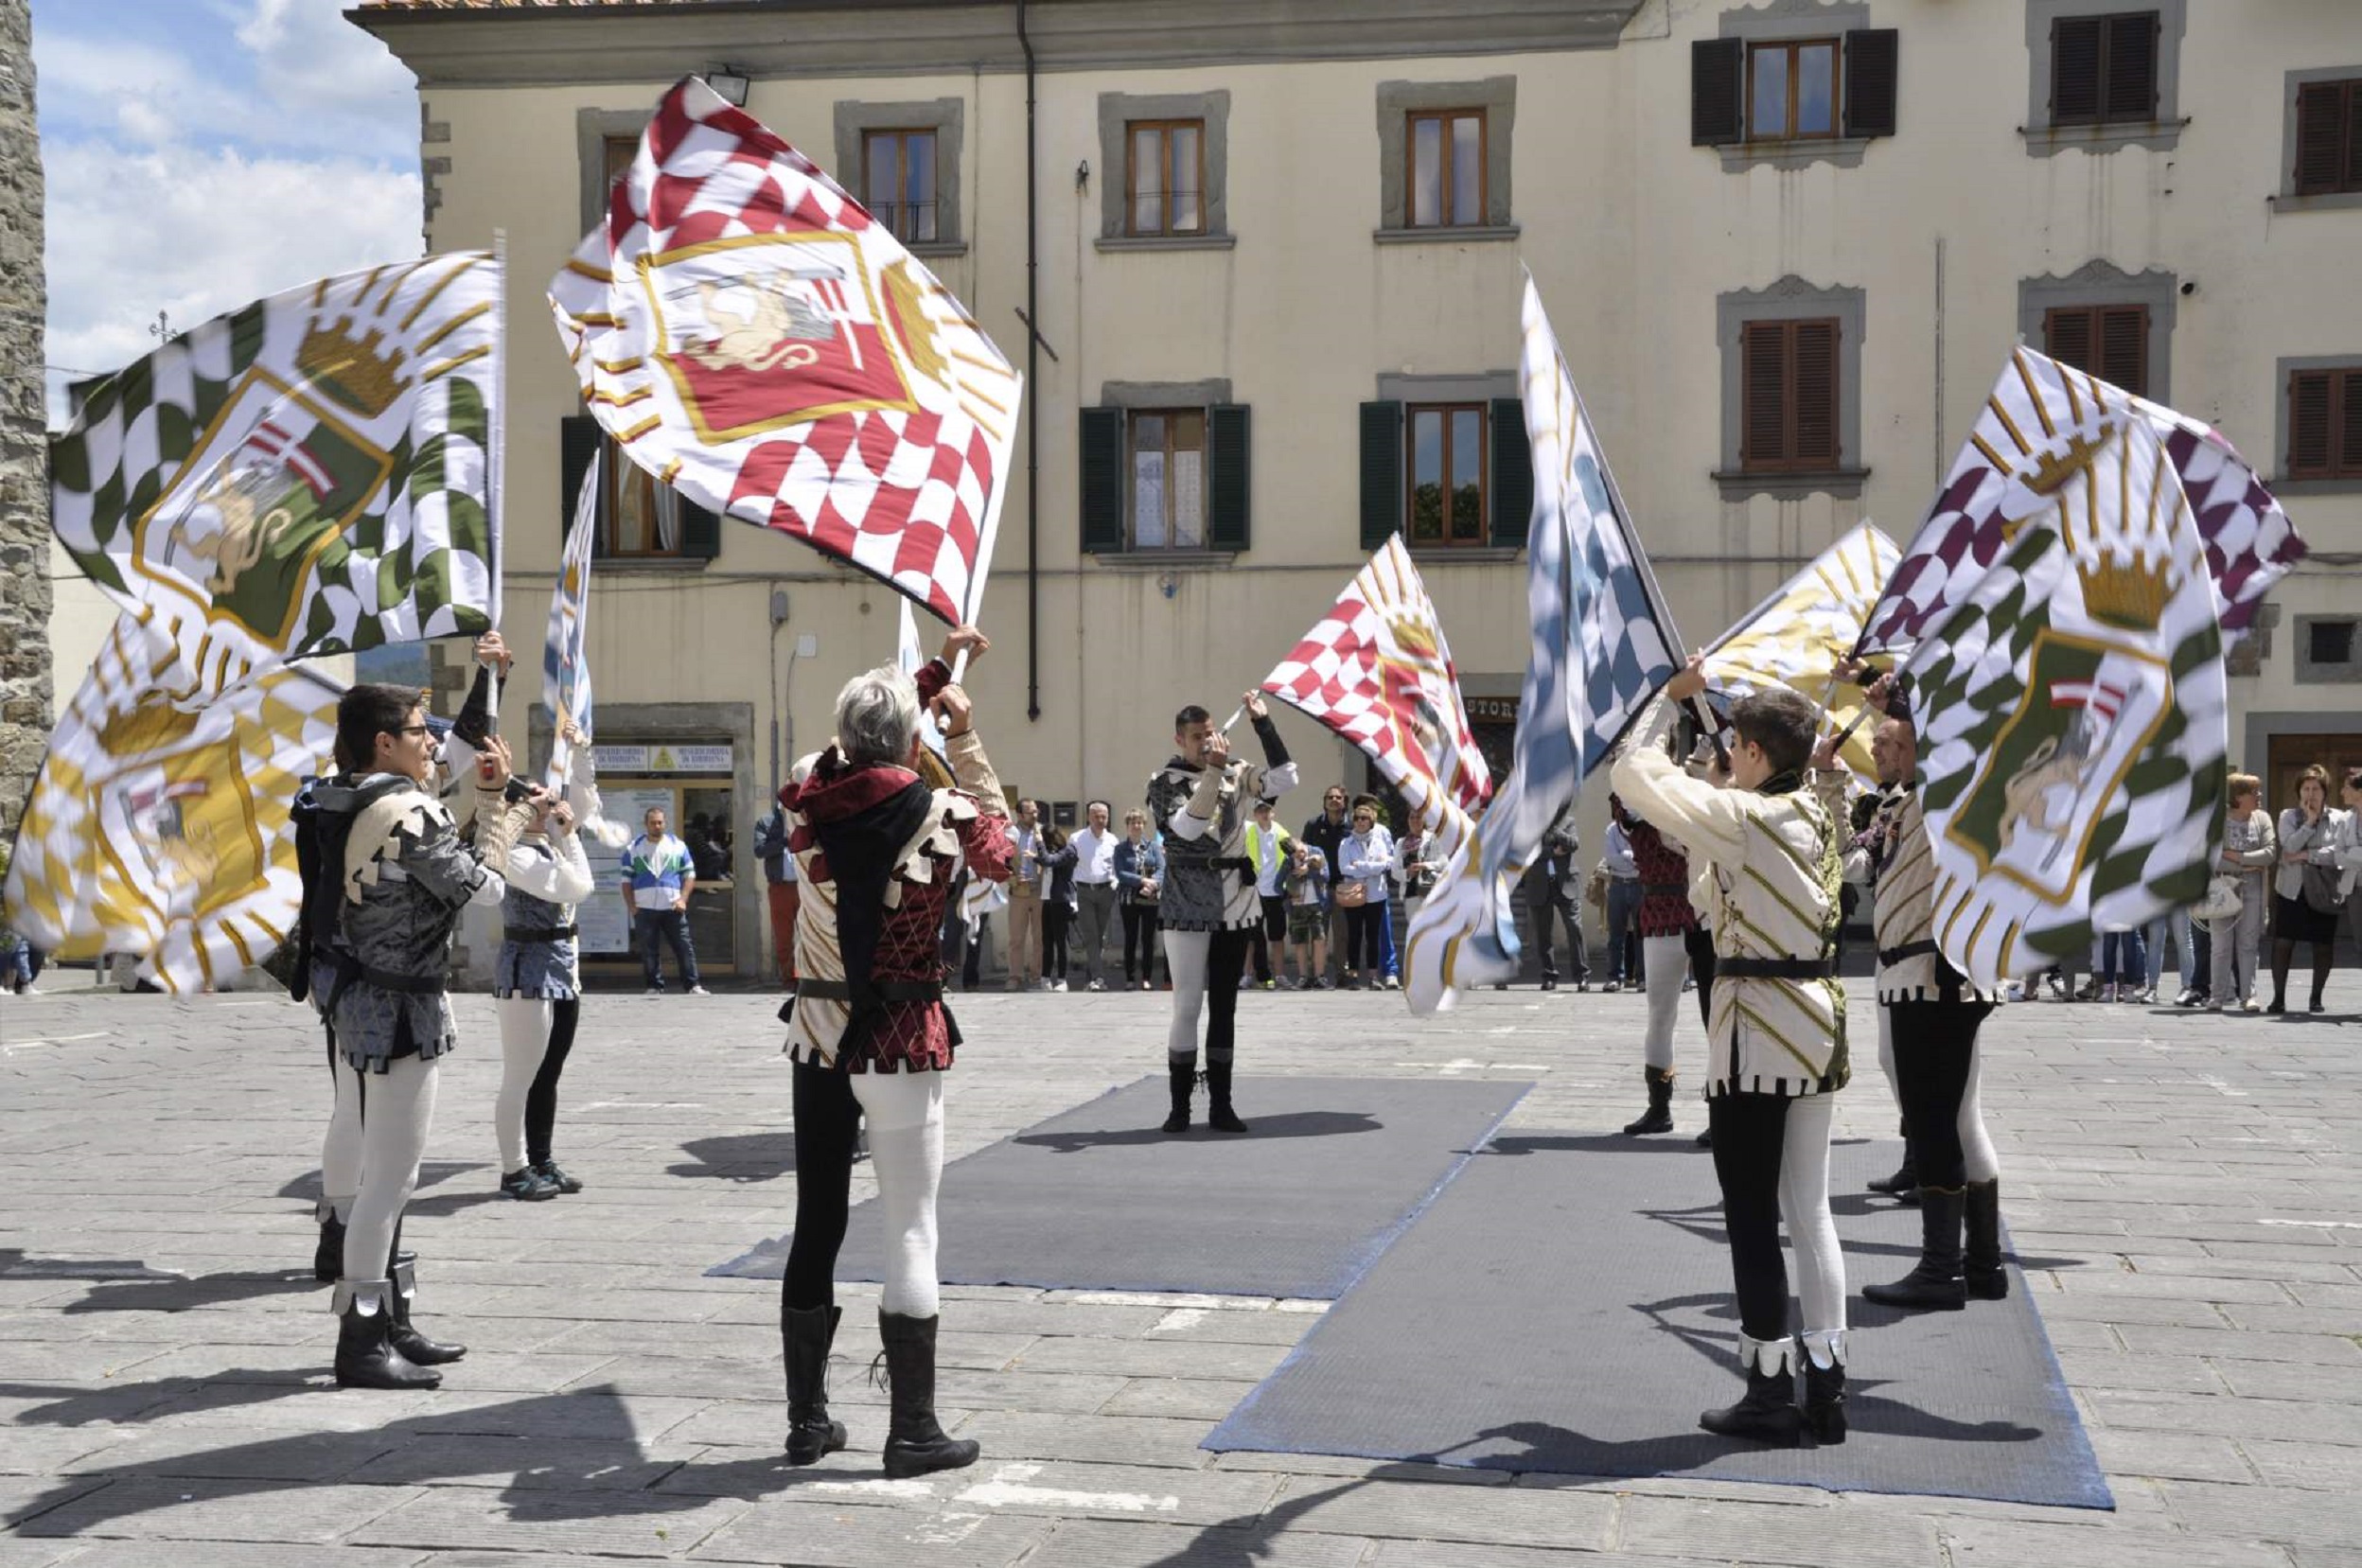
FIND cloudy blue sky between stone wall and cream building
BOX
[33,0,420,420]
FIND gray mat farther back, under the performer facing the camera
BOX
[709,1077,1530,1299]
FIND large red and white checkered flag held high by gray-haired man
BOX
[551,78,1023,625]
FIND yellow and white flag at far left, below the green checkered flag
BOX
[7,611,343,992]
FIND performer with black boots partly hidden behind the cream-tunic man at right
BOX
[1814,676,2010,1311]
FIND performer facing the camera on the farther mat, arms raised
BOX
[1148,692,1296,1134]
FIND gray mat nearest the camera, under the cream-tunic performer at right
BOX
[1205,1129,2116,1509]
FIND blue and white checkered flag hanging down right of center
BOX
[1403,276,1682,1013]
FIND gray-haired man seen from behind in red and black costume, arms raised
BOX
[780,625,1014,1478]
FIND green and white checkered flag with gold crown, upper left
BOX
[52,251,501,690]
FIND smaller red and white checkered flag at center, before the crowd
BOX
[1263,534,1492,853]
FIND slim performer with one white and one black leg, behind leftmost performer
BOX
[491,744,597,1202]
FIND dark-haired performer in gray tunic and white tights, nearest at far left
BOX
[297,685,538,1388]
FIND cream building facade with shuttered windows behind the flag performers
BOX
[352,0,2362,971]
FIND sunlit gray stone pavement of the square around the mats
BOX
[0,973,2362,1568]
